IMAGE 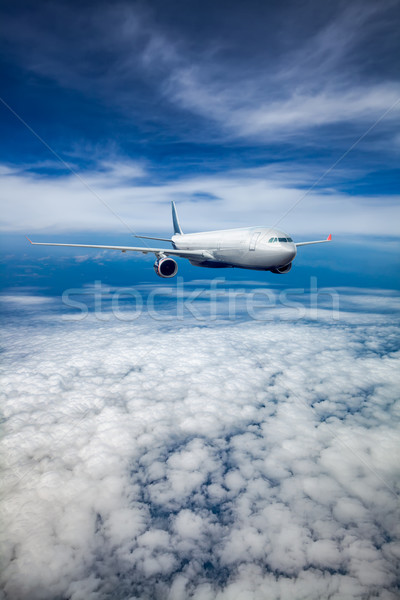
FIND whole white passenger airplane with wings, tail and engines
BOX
[27,201,332,278]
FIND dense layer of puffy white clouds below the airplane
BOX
[1,296,400,600]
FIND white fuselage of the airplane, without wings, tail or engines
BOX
[172,227,297,270]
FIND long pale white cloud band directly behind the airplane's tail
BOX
[0,163,400,237]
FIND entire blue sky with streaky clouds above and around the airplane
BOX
[0,1,400,288]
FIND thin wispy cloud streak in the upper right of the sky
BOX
[162,3,400,141]
